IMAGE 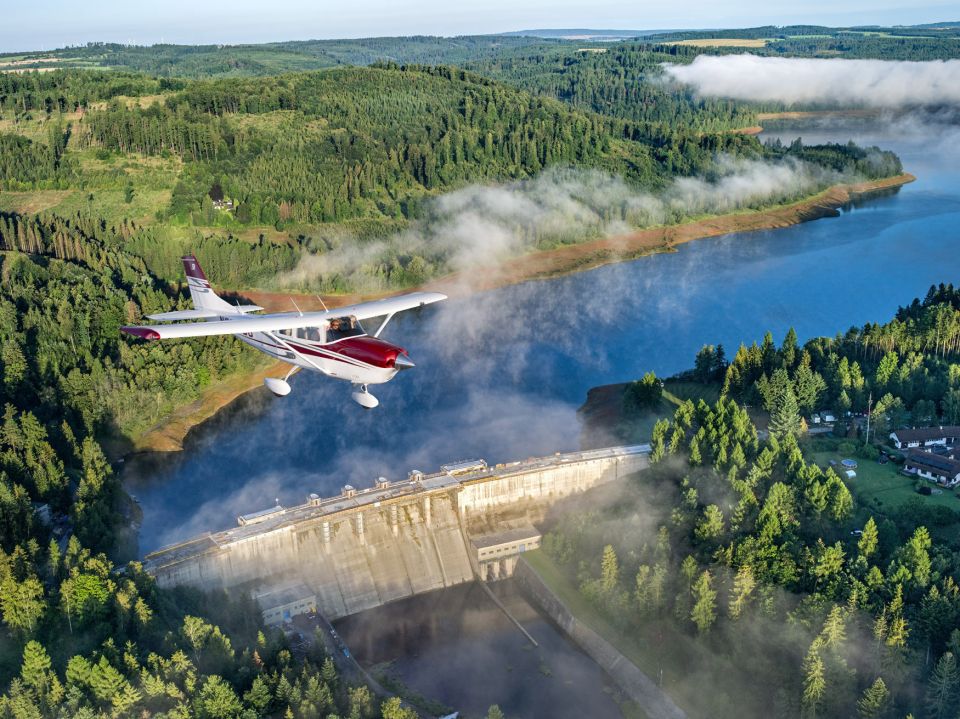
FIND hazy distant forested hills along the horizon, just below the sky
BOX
[11,22,960,76]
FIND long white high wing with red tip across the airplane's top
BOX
[120,292,447,340]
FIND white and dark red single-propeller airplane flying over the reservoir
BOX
[120,255,447,409]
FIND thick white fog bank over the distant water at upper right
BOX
[665,54,960,109]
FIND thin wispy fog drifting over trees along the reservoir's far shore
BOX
[275,157,843,291]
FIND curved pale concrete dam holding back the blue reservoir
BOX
[144,445,649,622]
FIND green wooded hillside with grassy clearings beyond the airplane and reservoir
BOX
[0,64,901,291]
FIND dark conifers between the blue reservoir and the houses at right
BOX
[684,284,960,436]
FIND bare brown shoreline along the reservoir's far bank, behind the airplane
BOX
[127,172,916,455]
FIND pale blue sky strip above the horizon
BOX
[0,0,960,52]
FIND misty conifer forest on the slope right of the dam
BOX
[544,285,960,719]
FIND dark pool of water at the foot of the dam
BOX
[336,579,623,719]
